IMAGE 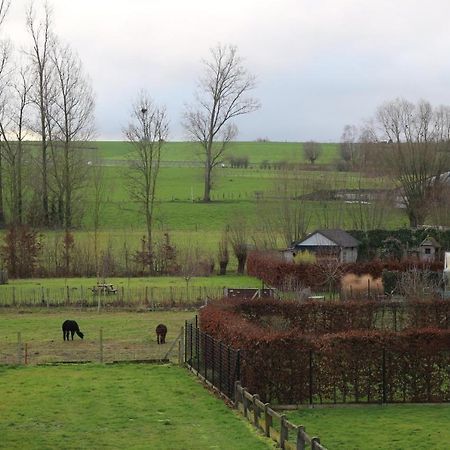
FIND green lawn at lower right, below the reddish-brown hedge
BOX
[287,404,450,450]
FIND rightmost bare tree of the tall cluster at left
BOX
[47,44,94,231]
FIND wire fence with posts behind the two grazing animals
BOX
[0,285,224,309]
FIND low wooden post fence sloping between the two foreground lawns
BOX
[234,381,326,450]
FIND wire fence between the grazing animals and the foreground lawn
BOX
[0,329,182,365]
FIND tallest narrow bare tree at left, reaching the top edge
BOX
[26,3,54,226]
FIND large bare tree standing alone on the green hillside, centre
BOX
[183,44,260,202]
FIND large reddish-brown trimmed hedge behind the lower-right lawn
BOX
[200,299,450,404]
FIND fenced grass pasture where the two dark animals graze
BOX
[0,308,195,364]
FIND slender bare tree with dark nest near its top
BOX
[124,91,169,270]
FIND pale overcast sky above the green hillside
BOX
[5,0,450,141]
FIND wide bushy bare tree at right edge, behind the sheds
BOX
[376,99,450,227]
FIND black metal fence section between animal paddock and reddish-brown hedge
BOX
[184,316,241,400]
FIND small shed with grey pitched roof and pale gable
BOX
[289,229,359,262]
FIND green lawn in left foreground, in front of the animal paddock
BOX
[0,365,273,450]
